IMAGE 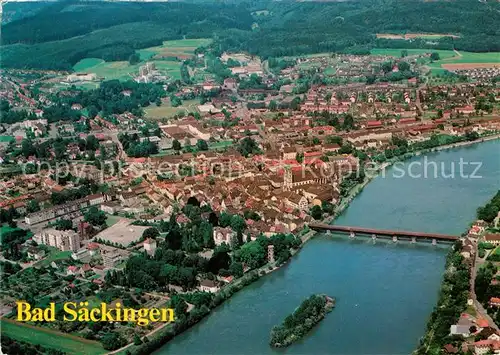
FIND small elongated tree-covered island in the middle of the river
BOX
[270,294,335,348]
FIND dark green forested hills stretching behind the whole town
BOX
[0,0,500,69]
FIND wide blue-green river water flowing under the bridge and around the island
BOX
[157,140,500,355]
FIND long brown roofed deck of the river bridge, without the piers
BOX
[309,223,458,241]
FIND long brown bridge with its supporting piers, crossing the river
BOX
[309,223,458,244]
